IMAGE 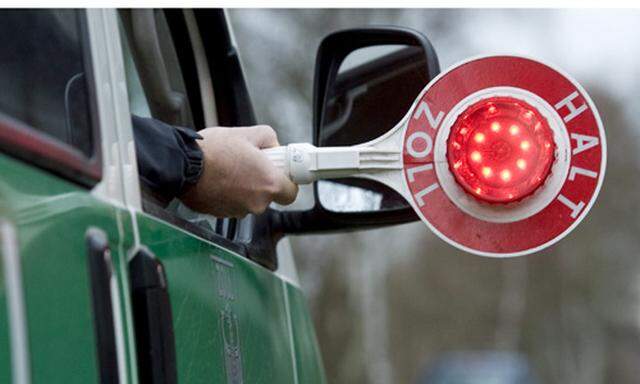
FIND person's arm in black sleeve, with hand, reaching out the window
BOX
[132,116,298,217]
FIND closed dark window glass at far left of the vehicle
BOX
[0,9,94,157]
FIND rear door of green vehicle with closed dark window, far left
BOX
[0,9,134,383]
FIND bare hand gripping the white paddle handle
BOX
[181,125,298,218]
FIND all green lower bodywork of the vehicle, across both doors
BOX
[0,155,326,383]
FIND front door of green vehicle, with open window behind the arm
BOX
[115,10,323,383]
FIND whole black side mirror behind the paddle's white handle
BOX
[280,27,440,233]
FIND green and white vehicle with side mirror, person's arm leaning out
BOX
[0,9,439,384]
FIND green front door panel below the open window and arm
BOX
[137,214,324,383]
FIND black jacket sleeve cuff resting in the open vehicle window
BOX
[131,115,203,200]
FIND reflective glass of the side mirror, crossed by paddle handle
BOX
[318,45,429,212]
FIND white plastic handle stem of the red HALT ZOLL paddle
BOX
[262,143,402,184]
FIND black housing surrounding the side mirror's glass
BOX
[274,27,440,234]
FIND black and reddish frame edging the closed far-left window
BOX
[0,10,102,188]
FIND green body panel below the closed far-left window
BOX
[0,155,137,383]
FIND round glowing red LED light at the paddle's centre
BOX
[447,96,555,203]
